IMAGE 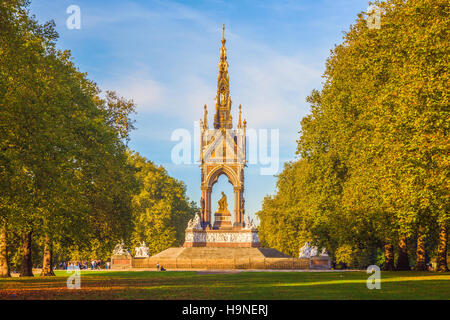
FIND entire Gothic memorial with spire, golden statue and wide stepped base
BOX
[112,26,316,269]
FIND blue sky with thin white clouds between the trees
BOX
[31,0,368,221]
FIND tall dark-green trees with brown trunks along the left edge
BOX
[0,0,139,276]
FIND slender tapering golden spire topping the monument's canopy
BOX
[214,24,233,129]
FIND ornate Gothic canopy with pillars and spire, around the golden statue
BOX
[200,25,246,229]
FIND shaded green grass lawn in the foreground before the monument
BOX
[0,271,450,300]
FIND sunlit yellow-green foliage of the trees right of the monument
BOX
[258,0,450,266]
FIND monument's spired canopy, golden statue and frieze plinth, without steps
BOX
[184,26,259,247]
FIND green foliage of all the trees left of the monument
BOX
[0,0,195,275]
